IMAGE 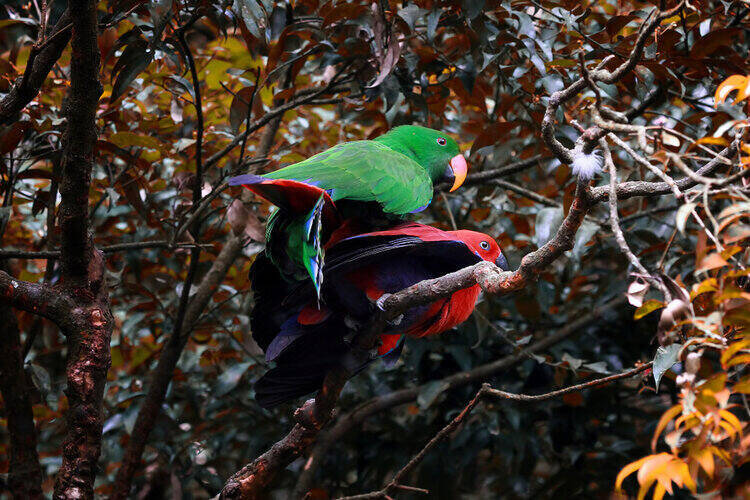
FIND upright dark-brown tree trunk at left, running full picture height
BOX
[54,0,114,499]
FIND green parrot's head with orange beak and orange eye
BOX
[375,125,468,191]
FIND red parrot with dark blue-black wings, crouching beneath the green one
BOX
[250,223,508,408]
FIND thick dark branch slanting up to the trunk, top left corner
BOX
[0,11,71,125]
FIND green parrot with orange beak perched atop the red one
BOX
[229,125,468,294]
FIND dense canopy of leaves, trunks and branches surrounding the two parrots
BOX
[0,0,750,499]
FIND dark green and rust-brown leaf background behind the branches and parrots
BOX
[0,0,750,499]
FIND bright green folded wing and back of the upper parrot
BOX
[263,141,433,215]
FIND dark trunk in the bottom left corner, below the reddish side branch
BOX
[0,264,44,499]
